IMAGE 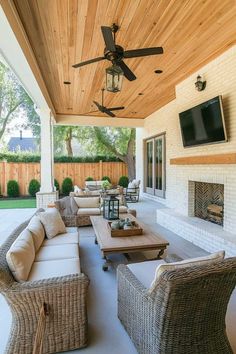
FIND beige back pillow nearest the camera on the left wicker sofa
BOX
[6,229,35,282]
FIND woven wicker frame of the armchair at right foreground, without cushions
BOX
[118,258,236,354]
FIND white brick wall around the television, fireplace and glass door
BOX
[136,46,236,252]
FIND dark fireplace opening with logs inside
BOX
[194,182,224,226]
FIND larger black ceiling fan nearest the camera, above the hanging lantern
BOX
[72,23,163,81]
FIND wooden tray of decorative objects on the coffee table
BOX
[108,218,143,237]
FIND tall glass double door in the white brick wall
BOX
[145,134,165,198]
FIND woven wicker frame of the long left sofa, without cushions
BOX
[0,217,89,354]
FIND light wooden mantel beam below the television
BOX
[170,152,236,165]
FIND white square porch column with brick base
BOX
[36,109,58,208]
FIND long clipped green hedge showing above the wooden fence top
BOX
[0,153,121,163]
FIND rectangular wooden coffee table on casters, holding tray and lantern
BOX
[90,214,169,271]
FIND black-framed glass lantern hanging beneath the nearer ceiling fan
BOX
[106,64,124,92]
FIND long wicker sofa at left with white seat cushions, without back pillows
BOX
[0,212,89,354]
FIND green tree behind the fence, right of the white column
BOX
[74,127,135,180]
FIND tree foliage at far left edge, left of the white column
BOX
[0,62,39,140]
